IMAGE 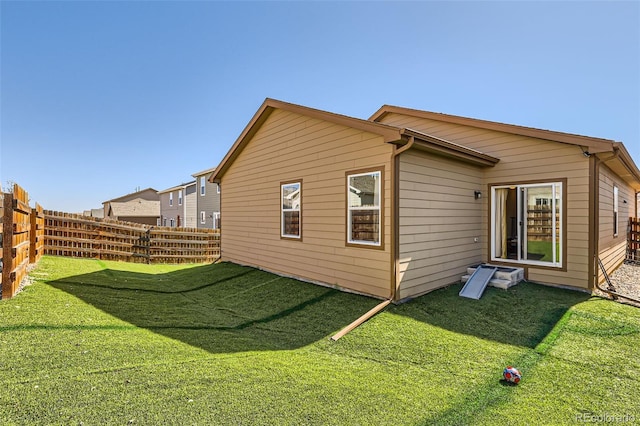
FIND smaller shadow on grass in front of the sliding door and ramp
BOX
[393,282,591,349]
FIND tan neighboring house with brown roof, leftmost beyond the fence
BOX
[102,188,160,225]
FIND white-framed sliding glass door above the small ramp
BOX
[491,182,564,267]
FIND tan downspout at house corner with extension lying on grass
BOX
[331,136,415,341]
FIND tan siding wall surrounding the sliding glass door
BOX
[380,113,589,288]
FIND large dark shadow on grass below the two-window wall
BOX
[48,263,379,353]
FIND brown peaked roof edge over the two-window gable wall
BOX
[209,98,499,182]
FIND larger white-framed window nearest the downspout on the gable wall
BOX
[347,170,382,246]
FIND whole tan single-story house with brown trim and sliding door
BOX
[211,99,640,301]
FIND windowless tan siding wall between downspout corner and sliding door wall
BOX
[398,150,483,299]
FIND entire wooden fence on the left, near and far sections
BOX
[0,184,220,299]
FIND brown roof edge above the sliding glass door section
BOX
[369,105,640,191]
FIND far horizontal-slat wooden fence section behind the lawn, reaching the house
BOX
[44,210,220,263]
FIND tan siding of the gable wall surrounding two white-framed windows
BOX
[221,109,391,297]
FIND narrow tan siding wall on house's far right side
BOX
[598,165,635,282]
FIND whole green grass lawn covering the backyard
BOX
[0,256,640,425]
